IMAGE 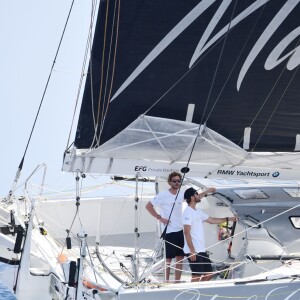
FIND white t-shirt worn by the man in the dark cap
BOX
[182,206,209,254]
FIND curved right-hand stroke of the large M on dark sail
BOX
[237,0,300,90]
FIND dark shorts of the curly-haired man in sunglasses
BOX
[165,230,184,258]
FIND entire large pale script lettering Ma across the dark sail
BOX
[111,0,300,101]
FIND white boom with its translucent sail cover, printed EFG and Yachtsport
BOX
[64,115,300,179]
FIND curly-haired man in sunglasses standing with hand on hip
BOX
[146,172,184,282]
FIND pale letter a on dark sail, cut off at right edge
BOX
[265,27,300,70]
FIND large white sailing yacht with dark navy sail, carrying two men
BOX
[0,0,300,300]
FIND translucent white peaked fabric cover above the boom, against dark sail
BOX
[86,115,248,165]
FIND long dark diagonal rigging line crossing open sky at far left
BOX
[8,0,74,200]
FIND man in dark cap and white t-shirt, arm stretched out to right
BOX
[182,188,237,282]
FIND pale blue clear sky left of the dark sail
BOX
[0,0,116,197]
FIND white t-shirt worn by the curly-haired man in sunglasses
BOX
[151,190,184,233]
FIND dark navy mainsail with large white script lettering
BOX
[75,0,300,151]
